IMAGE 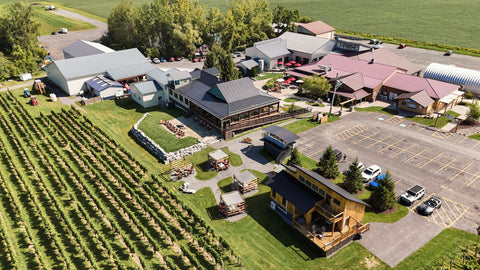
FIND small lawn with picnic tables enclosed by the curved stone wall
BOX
[138,110,198,152]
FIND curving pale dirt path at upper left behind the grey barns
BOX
[38,10,108,60]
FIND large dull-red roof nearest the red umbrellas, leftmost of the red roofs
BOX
[294,53,398,89]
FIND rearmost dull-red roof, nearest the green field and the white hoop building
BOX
[352,48,422,74]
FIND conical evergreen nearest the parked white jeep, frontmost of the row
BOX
[370,171,396,212]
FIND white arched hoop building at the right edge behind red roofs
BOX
[423,63,480,94]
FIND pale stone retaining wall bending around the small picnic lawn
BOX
[130,112,207,164]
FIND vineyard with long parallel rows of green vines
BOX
[0,92,234,269]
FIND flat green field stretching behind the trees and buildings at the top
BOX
[0,0,480,49]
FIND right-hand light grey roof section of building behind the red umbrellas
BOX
[278,32,335,54]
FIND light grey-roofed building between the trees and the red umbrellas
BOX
[245,32,335,70]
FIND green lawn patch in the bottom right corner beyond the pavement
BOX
[395,229,479,270]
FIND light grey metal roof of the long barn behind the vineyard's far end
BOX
[47,49,147,80]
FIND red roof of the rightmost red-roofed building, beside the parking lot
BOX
[384,73,460,99]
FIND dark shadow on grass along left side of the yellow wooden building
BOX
[245,192,321,261]
